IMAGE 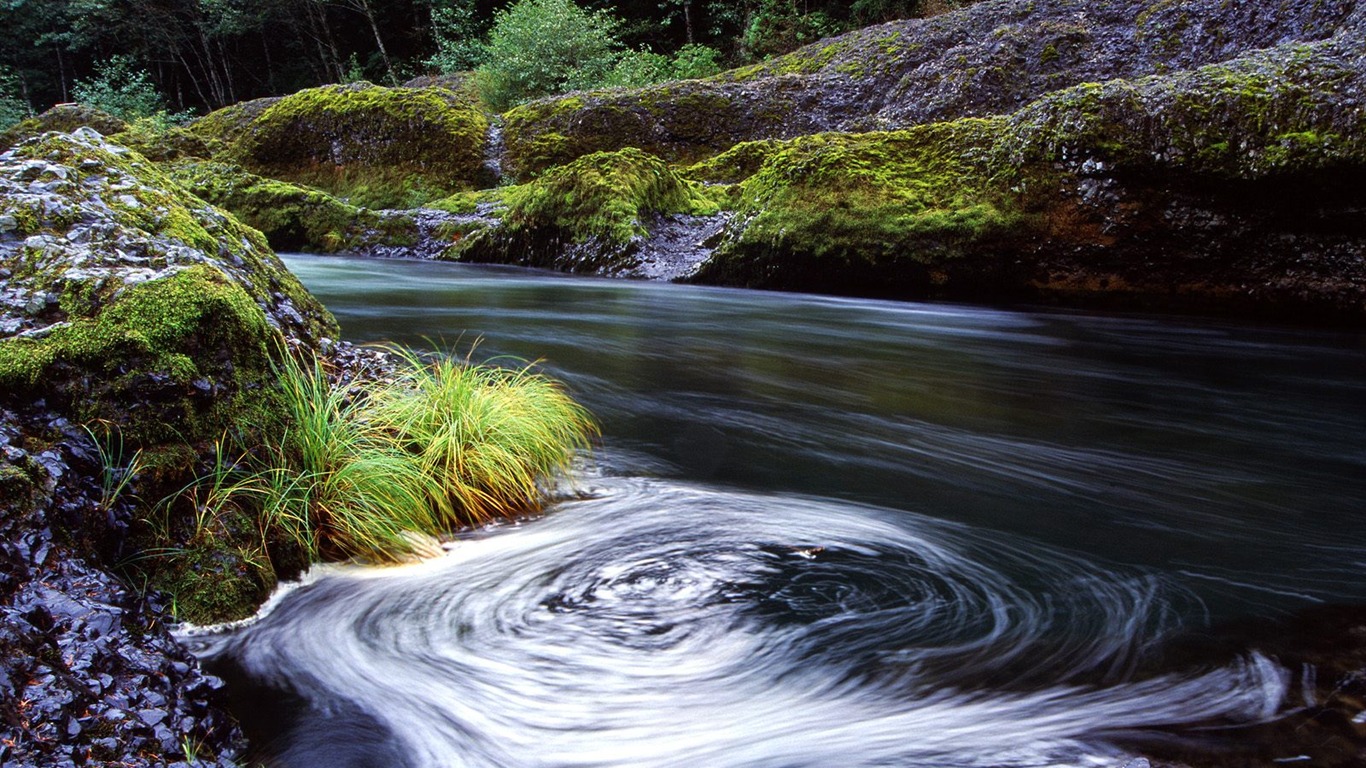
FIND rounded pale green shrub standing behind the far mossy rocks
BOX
[478,0,620,109]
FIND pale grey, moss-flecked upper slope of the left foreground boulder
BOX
[0,130,336,343]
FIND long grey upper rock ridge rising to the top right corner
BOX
[505,0,1361,179]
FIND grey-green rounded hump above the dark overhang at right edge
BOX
[1001,41,1366,179]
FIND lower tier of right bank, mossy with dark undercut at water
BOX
[690,36,1366,324]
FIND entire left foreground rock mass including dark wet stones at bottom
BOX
[0,128,336,765]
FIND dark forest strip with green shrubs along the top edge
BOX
[0,0,966,120]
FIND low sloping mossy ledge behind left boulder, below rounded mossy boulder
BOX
[168,160,417,253]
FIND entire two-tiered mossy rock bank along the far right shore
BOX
[467,0,1366,324]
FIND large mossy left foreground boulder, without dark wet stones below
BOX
[0,128,337,618]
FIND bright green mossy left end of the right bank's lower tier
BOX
[697,118,1030,295]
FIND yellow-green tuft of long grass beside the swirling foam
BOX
[206,350,596,560]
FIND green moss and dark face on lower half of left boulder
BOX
[0,265,275,447]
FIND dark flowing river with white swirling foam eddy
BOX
[181,257,1366,768]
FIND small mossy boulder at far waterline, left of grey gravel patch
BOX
[445,148,717,275]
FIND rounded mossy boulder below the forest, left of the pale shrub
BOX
[229,83,492,208]
